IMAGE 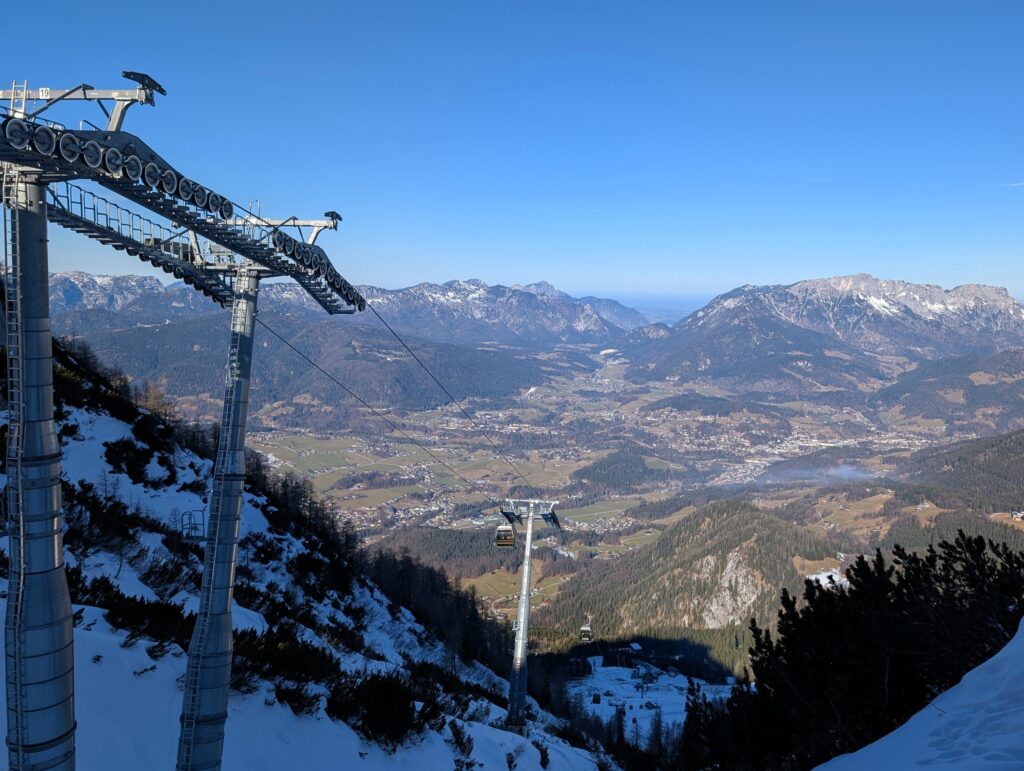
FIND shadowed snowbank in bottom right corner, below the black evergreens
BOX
[818,618,1024,771]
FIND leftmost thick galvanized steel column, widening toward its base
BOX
[4,177,75,771]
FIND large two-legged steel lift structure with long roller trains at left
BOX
[0,72,366,771]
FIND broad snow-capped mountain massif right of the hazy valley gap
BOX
[620,274,1024,393]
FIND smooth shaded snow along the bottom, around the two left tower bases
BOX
[0,603,595,771]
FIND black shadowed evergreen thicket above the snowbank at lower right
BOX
[675,532,1024,771]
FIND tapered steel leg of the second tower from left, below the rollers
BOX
[177,264,260,771]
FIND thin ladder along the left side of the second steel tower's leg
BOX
[178,290,245,769]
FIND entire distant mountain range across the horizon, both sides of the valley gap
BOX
[50,272,1024,436]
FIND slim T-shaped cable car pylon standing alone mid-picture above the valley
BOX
[495,499,562,735]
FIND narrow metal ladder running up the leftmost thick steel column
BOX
[0,159,26,768]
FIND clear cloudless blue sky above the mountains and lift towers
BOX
[8,0,1024,297]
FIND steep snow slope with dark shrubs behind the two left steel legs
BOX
[0,376,596,771]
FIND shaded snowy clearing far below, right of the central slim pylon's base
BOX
[568,656,732,746]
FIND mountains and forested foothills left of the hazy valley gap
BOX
[50,272,646,429]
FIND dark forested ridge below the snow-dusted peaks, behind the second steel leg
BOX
[57,311,572,430]
